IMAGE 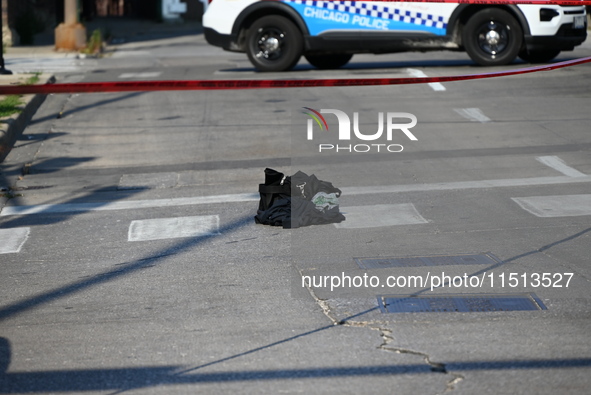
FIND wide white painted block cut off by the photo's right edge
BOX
[512,195,591,218]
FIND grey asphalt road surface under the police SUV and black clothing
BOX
[0,26,591,394]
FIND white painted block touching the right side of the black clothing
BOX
[334,203,428,229]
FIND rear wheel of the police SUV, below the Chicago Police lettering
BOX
[246,15,304,71]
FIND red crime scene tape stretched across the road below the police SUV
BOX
[0,57,591,95]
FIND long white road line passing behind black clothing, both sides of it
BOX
[0,176,591,217]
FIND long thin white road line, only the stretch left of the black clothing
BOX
[0,193,260,217]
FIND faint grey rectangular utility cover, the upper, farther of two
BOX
[354,253,501,269]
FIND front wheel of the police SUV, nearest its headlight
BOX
[462,8,523,66]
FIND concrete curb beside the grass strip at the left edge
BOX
[0,75,55,163]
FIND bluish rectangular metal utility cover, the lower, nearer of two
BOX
[378,293,547,313]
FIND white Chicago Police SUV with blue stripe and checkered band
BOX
[203,0,587,71]
